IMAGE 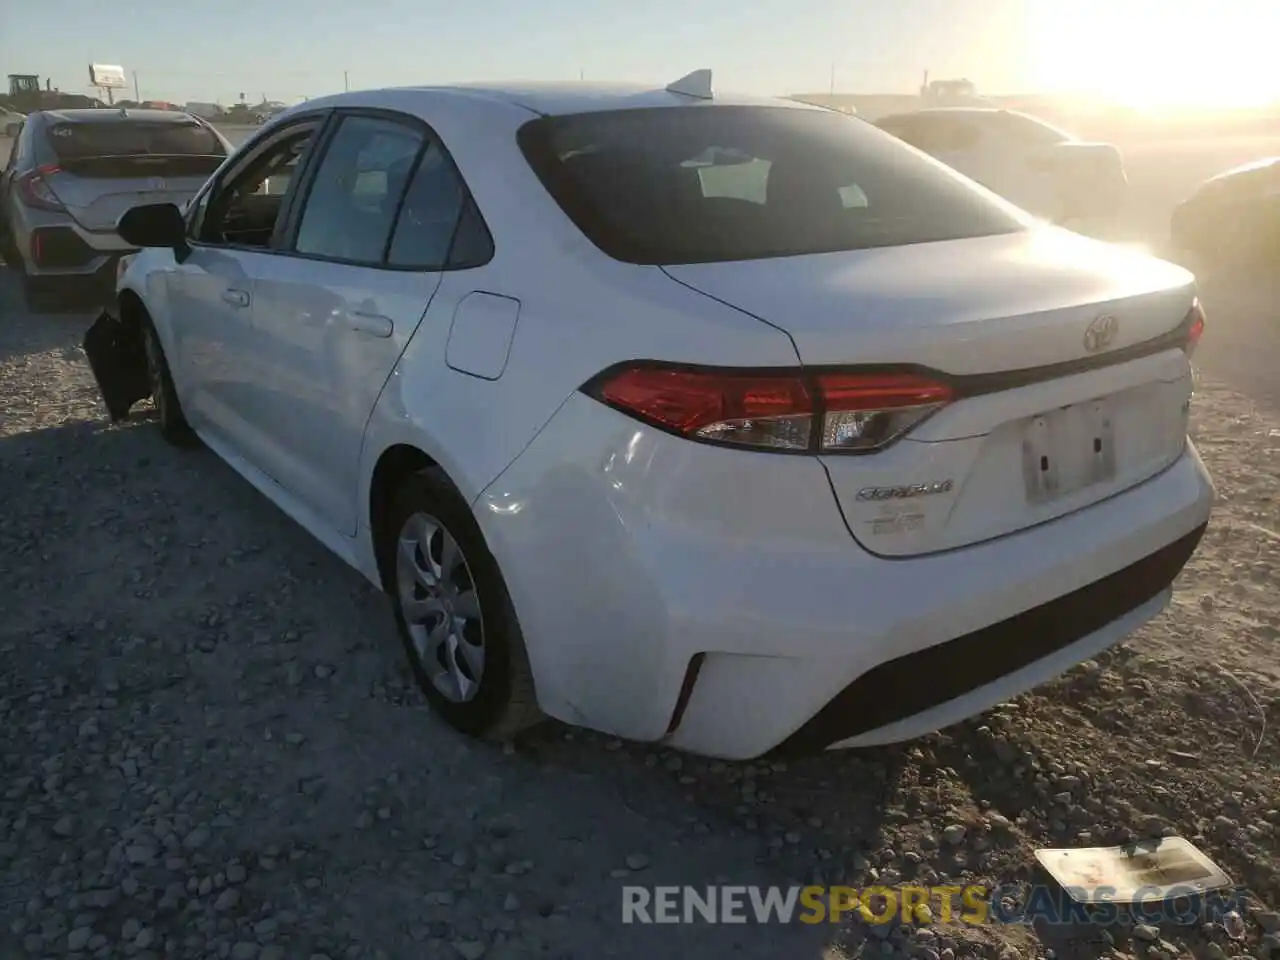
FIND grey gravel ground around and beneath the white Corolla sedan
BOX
[0,259,1280,960]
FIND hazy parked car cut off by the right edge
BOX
[1170,156,1280,271]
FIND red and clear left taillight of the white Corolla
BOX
[586,364,951,453]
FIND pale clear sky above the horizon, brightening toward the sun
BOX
[0,0,1280,106]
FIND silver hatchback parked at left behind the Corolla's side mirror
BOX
[0,109,233,311]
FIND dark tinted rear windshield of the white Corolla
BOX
[518,106,1025,264]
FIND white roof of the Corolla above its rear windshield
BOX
[291,81,826,116]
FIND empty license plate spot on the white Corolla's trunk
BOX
[1023,399,1116,504]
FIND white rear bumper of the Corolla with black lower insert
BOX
[475,396,1213,759]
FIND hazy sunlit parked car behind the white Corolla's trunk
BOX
[876,108,1128,228]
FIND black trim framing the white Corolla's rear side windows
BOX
[271,106,497,274]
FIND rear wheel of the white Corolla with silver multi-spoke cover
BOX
[379,468,543,740]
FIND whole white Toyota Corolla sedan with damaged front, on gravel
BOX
[86,72,1213,758]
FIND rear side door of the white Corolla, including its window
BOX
[253,110,483,536]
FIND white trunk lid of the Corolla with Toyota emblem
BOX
[666,229,1194,557]
